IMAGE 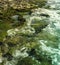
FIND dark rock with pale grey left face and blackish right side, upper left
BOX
[11,15,26,27]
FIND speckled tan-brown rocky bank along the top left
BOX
[0,0,37,11]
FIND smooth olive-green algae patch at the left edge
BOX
[0,22,11,41]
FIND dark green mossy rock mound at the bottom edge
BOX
[17,57,40,65]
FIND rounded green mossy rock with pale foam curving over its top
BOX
[31,17,48,32]
